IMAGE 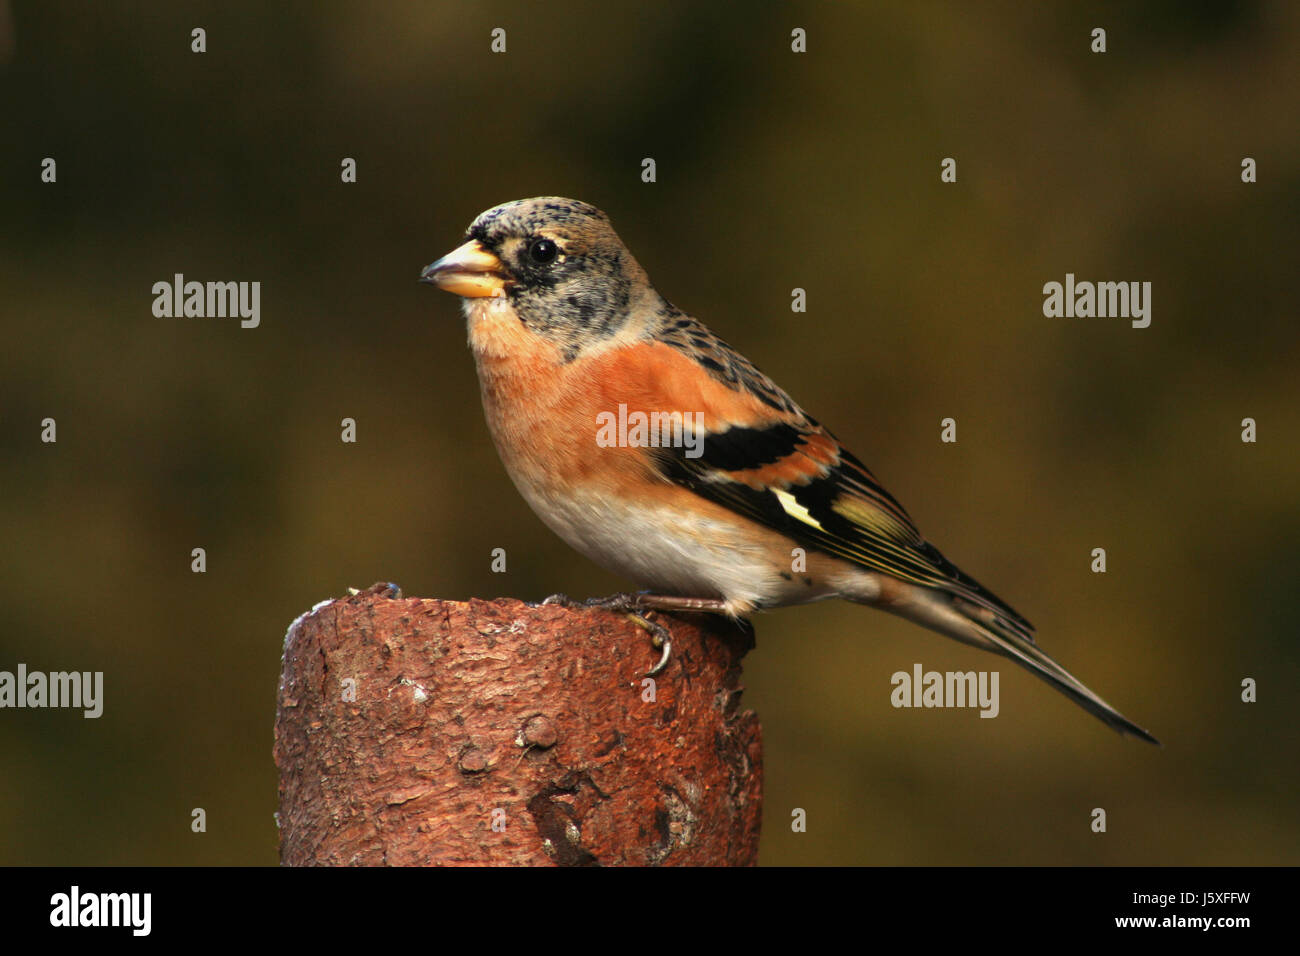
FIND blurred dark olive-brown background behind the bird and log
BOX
[0,0,1300,865]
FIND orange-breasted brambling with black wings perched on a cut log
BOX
[421,196,1156,743]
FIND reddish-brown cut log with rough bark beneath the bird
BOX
[274,584,762,865]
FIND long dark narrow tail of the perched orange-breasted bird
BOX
[872,585,1160,745]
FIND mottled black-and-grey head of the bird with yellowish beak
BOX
[420,196,654,352]
